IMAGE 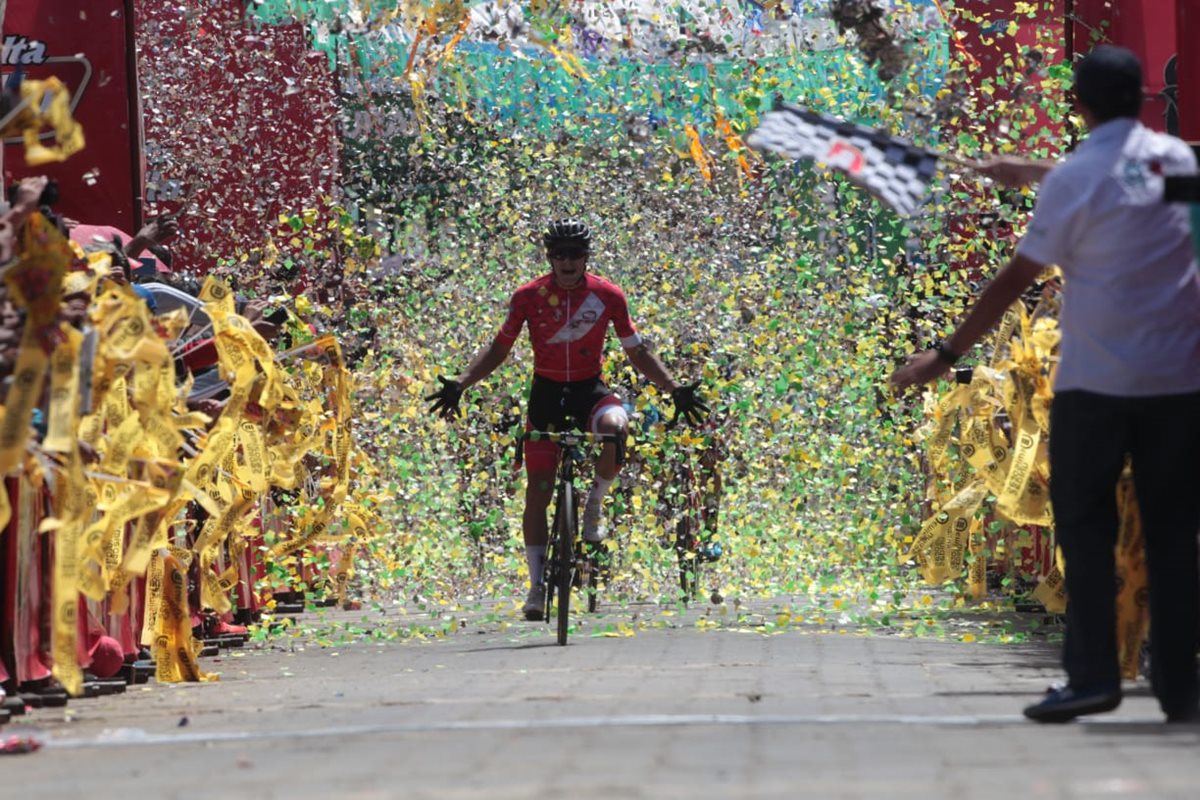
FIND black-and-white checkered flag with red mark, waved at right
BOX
[746,103,938,217]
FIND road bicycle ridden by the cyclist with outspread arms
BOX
[517,431,625,644]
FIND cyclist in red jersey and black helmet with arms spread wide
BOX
[426,218,708,621]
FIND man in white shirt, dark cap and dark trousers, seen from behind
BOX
[893,46,1200,722]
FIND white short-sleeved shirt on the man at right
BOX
[1016,119,1200,397]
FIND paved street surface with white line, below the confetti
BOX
[0,610,1200,800]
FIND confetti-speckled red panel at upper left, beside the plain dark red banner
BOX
[134,0,338,271]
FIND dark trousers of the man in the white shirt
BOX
[1050,391,1200,712]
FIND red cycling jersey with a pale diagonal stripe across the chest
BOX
[496,272,642,383]
